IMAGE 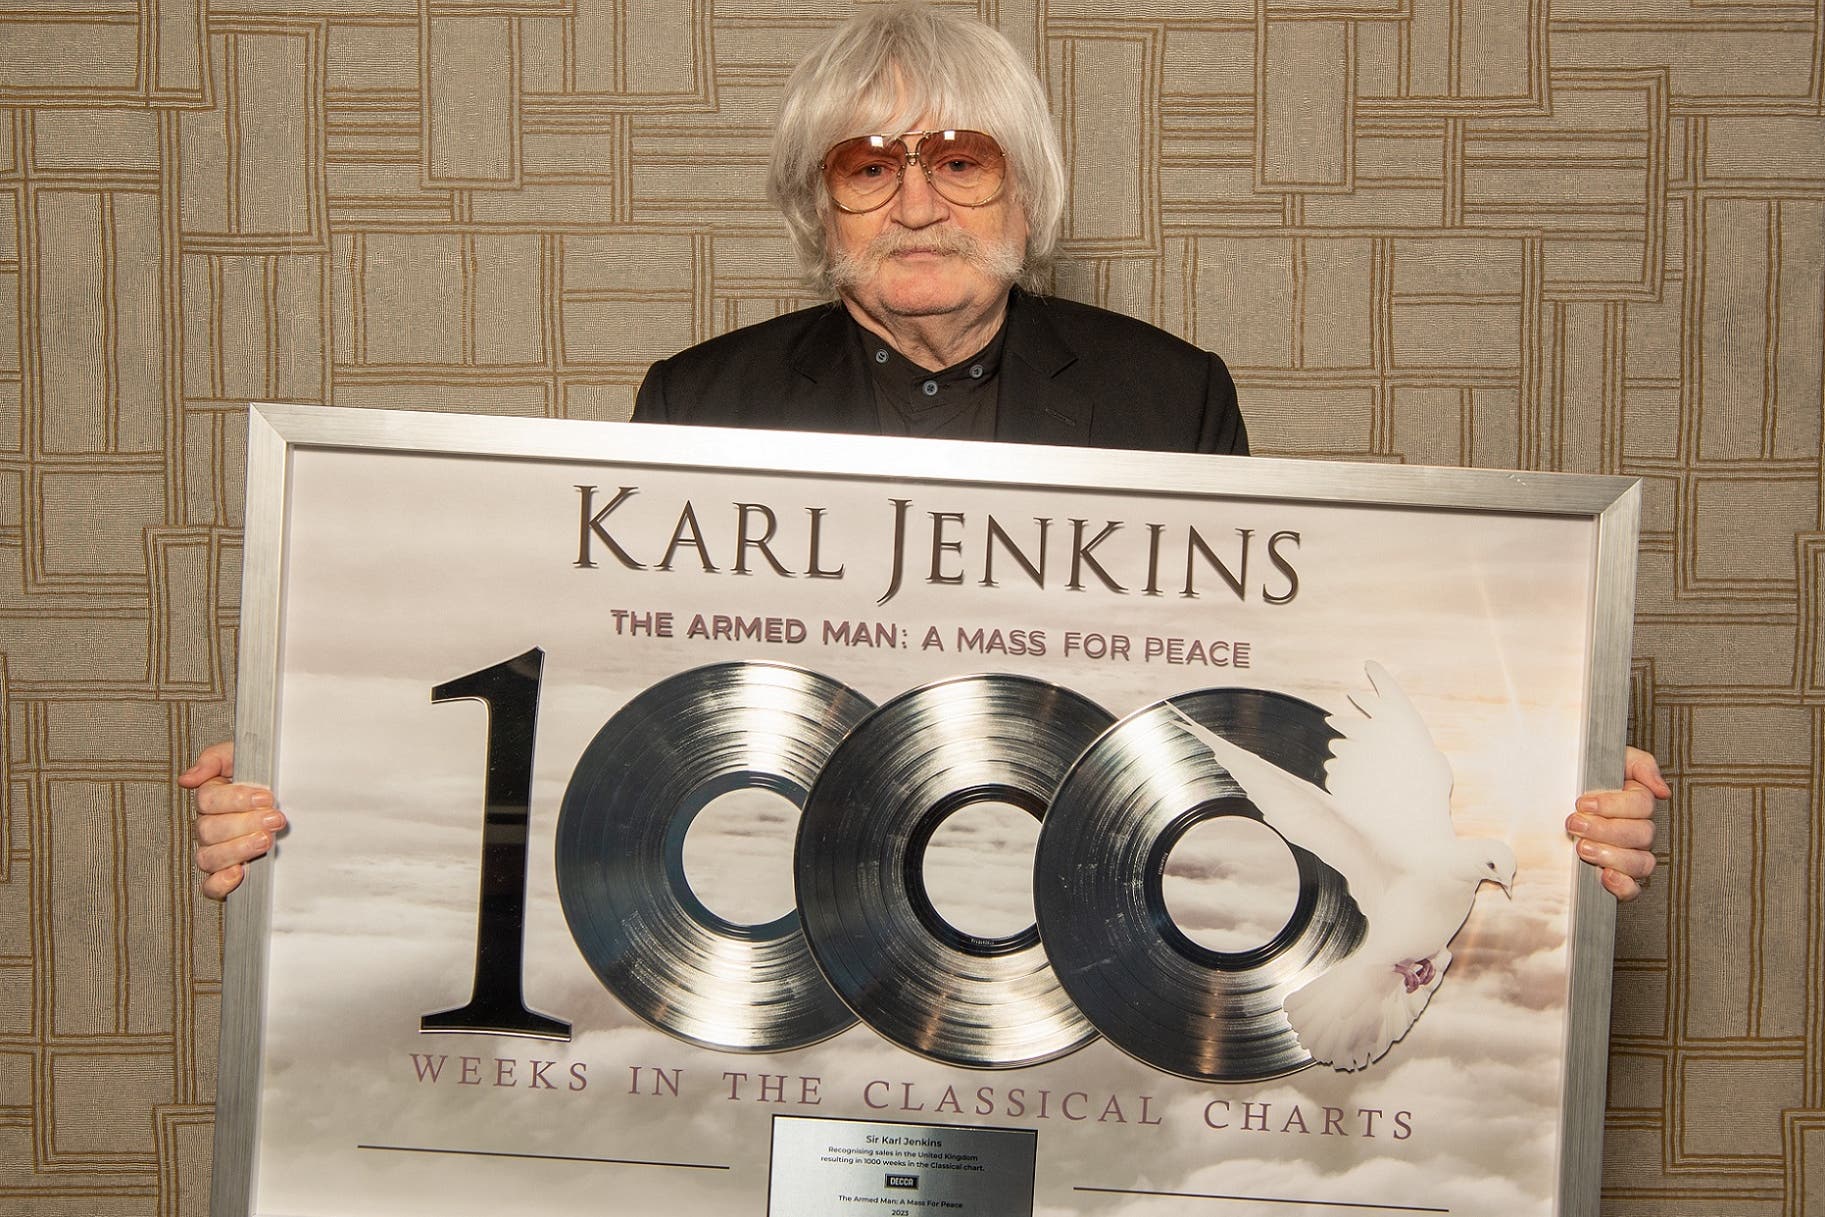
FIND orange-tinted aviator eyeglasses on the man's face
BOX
[818,131,1007,215]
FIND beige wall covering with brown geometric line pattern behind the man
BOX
[0,0,1825,1217]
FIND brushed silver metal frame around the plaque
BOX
[210,403,1641,1217]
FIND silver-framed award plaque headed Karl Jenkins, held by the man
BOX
[212,405,1639,1217]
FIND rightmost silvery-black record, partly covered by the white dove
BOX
[1033,690,1367,1082]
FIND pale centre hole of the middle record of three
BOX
[923,801,1038,938]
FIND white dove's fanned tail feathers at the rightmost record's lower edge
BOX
[1285,951,1451,1071]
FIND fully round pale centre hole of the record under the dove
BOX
[1161,816,1299,954]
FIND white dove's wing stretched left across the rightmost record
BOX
[1173,706,1392,923]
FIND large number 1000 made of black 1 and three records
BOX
[420,648,1365,1078]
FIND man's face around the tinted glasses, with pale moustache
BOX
[825,117,1027,319]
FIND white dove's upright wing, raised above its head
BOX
[1325,661,1456,853]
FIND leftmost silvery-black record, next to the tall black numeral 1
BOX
[557,662,872,1051]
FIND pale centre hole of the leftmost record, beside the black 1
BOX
[684,788,799,925]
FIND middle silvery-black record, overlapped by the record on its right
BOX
[794,673,1111,1067]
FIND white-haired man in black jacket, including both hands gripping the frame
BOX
[179,5,1670,900]
